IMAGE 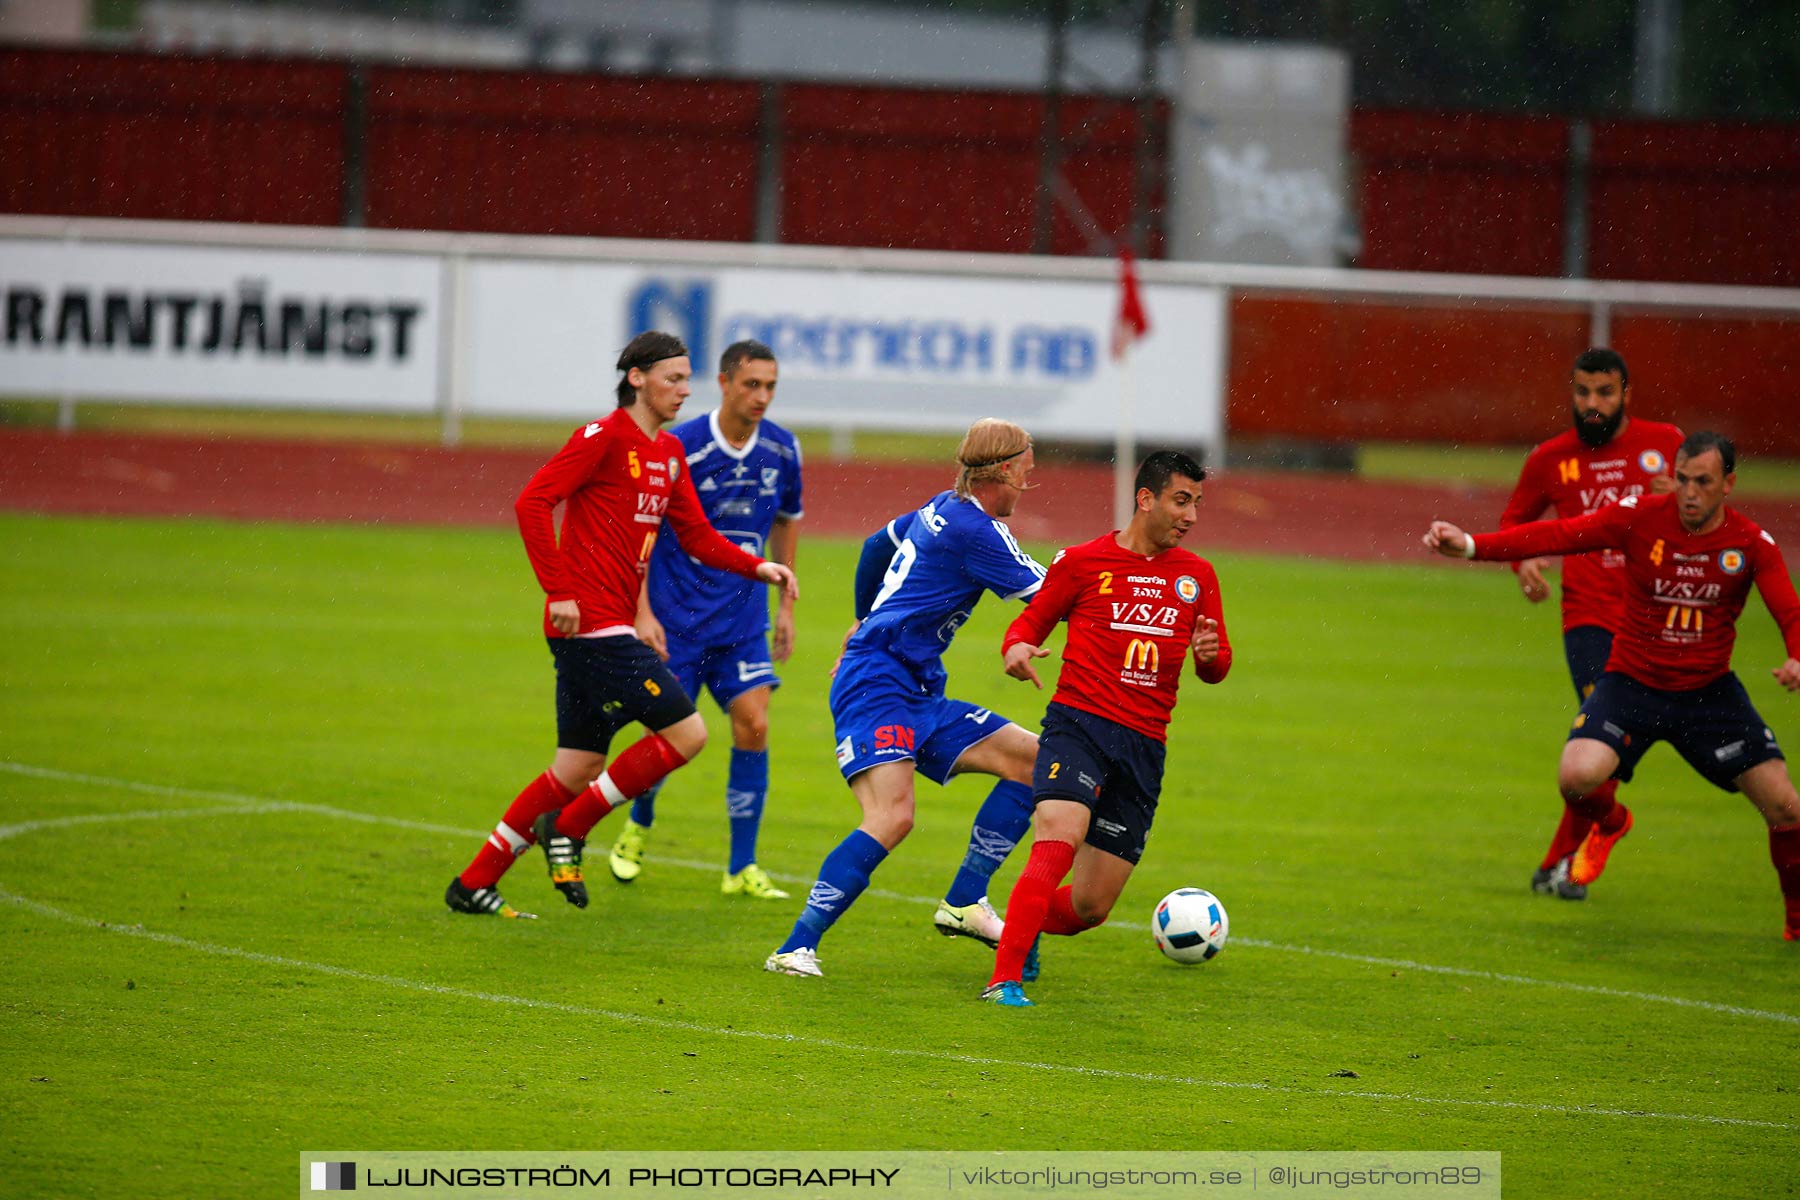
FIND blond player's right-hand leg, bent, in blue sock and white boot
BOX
[931,723,1037,950]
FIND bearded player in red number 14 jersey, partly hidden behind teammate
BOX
[1499,347,1681,900]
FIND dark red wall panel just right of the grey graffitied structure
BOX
[1350,112,1568,275]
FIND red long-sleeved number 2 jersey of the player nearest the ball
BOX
[1001,533,1231,741]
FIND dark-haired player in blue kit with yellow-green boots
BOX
[608,342,801,900]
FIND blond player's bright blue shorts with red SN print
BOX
[832,651,1012,784]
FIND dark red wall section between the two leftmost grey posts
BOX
[367,68,760,241]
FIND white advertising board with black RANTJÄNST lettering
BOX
[0,237,443,412]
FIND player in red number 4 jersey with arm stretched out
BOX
[1424,434,1800,941]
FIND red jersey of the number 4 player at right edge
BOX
[1474,495,1800,691]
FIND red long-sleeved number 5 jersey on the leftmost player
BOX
[513,408,763,637]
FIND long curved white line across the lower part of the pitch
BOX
[0,881,1800,1132]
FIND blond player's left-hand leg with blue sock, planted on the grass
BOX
[763,759,913,975]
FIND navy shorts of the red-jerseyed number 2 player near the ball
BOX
[1031,702,1168,864]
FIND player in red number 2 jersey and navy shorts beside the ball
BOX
[981,450,1231,1007]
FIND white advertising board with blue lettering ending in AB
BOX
[463,259,1224,446]
